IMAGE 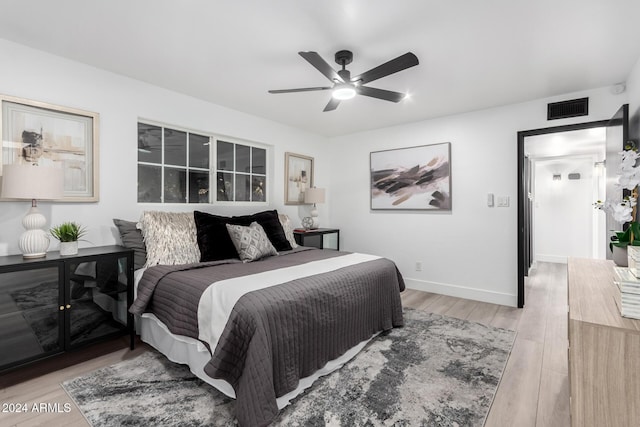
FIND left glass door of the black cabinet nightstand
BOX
[0,267,64,368]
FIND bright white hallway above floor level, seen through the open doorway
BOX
[524,127,607,265]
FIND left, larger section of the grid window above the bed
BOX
[138,123,211,203]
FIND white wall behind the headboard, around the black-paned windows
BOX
[0,39,330,255]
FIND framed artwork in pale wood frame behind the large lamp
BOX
[0,95,99,202]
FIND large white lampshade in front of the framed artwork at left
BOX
[2,164,64,200]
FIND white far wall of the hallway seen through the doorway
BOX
[533,156,598,263]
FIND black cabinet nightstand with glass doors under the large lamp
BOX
[0,246,135,371]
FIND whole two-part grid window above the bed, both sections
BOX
[138,122,267,203]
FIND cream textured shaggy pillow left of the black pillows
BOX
[138,211,200,267]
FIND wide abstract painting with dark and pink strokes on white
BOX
[370,142,451,210]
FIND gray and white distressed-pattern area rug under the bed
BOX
[63,309,515,427]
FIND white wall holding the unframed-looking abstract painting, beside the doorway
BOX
[330,88,627,306]
